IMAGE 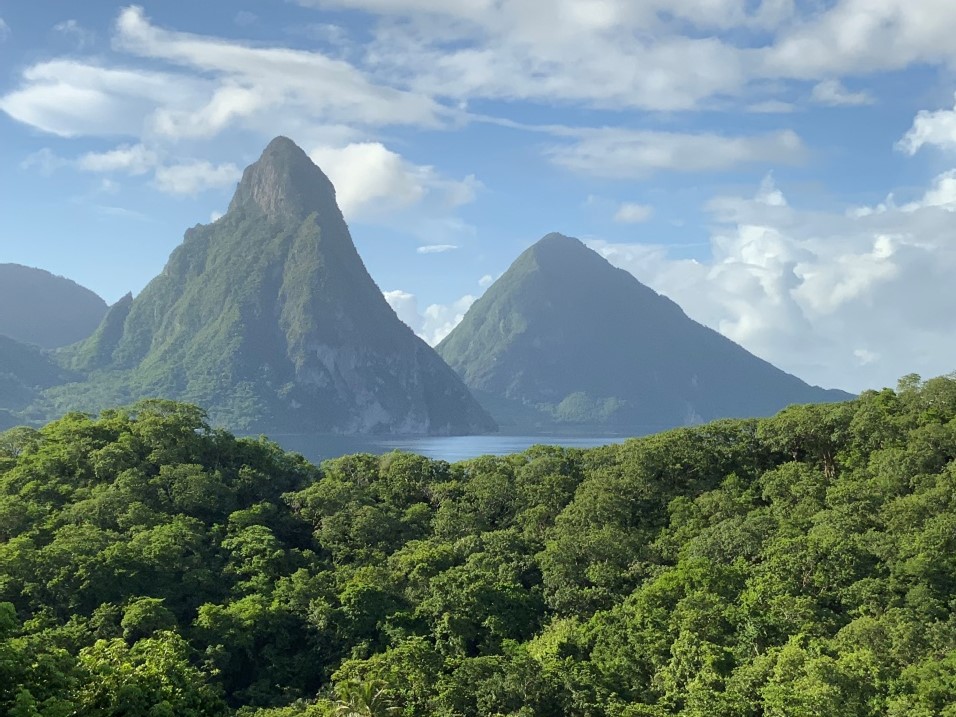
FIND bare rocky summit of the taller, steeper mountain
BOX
[229,137,341,220]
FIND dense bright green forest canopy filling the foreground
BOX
[0,376,956,717]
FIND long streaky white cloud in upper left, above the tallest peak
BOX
[0,6,443,140]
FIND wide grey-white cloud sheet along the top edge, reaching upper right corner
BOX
[299,0,956,112]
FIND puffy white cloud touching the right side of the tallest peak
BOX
[310,142,481,220]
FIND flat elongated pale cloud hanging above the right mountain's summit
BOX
[548,128,806,179]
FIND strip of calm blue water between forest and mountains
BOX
[271,435,628,463]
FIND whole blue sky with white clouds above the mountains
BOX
[0,0,956,391]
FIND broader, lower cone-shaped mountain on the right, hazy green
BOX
[438,234,850,433]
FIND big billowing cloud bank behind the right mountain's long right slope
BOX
[592,171,956,390]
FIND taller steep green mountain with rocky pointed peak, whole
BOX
[63,137,495,434]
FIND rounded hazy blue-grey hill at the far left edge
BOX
[0,264,106,348]
